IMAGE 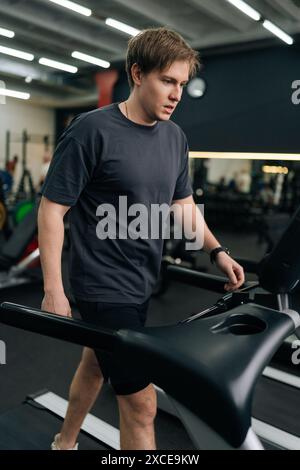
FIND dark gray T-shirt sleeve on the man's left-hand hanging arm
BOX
[41,137,97,206]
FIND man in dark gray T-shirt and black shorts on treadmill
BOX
[39,28,244,450]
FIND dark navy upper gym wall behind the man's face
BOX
[114,44,300,153]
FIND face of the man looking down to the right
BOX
[139,61,189,121]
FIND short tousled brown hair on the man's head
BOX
[126,27,200,89]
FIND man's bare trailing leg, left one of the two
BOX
[58,348,103,450]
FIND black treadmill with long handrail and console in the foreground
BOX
[0,205,300,450]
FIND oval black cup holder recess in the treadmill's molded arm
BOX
[211,314,267,336]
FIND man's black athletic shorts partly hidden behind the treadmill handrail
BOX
[76,299,150,395]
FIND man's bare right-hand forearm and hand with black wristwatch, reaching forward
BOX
[172,196,245,292]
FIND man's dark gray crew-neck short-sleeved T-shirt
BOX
[42,104,192,304]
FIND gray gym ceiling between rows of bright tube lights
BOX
[0,0,300,107]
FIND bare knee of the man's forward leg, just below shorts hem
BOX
[117,385,157,426]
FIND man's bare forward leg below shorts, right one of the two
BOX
[117,384,157,450]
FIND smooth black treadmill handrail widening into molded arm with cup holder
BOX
[0,302,295,448]
